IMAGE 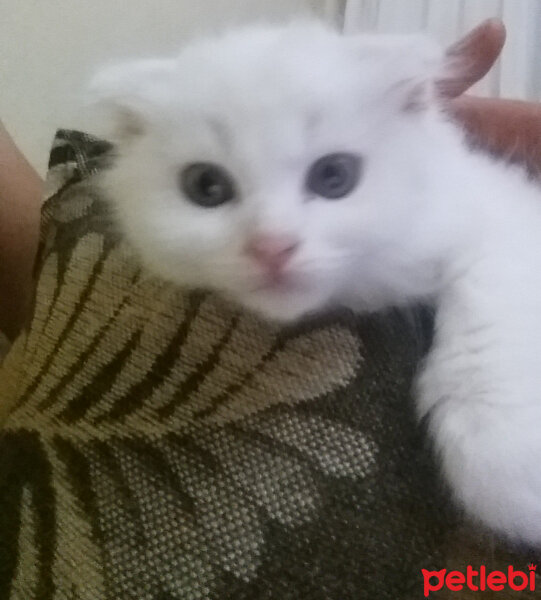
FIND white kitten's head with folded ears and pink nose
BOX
[88,24,460,319]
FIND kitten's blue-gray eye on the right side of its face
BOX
[306,152,362,200]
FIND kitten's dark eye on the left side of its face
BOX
[179,163,235,208]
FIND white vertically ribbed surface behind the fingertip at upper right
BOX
[343,0,541,100]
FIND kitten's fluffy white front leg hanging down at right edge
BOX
[418,253,541,545]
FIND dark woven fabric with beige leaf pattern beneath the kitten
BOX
[0,131,532,600]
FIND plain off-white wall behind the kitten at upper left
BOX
[0,0,340,173]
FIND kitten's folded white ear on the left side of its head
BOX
[86,60,175,143]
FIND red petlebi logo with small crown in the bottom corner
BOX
[421,564,537,598]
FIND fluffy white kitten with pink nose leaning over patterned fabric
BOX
[87,24,541,544]
